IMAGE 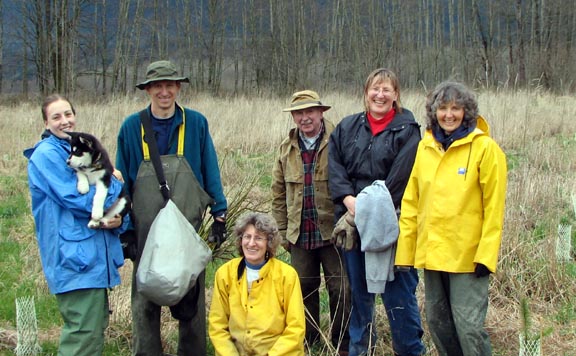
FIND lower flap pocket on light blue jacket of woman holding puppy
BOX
[59,226,97,272]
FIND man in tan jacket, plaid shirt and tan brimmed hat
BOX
[272,90,350,355]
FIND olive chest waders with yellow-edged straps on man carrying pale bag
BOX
[132,109,213,356]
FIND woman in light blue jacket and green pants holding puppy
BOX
[24,94,128,356]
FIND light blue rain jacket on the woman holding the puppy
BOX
[24,135,129,294]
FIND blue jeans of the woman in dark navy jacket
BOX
[344,248,425,356]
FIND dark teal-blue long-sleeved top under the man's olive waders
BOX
[116,105,227,215]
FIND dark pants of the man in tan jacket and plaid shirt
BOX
[290,245,350,350]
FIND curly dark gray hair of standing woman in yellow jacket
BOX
[426,81,478,129]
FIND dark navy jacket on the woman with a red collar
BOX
[328,109,421,221]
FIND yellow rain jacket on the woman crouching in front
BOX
[208,257,306,356]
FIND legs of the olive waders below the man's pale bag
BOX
[132,262,206,356]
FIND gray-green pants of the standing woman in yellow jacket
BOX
[424,270,492,356]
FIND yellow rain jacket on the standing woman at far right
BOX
[395,116,507,273]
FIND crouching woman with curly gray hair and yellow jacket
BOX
[208,213,306,356]
